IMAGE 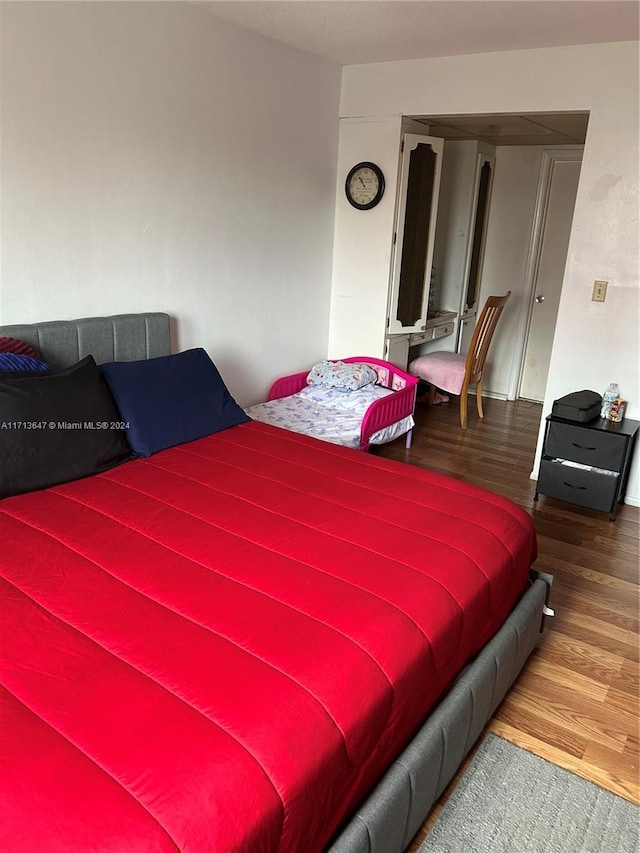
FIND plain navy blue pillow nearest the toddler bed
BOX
[100,347,251,456]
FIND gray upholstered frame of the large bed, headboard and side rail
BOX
[0,313,553,853]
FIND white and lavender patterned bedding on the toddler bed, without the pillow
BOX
[246,385,415,448]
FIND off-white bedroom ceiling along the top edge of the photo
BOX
[196,0,640,65]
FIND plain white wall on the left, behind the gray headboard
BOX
[0,2,341,403]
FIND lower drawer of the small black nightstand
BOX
[538,459,618,511]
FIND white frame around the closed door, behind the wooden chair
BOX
[507,145,584,400]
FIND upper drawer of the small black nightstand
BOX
[544,423,626,471]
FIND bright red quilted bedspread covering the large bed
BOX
[0,423,535,853]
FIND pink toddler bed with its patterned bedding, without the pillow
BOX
[246,356,418,450]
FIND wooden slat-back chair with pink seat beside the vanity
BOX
[409,291,511,429]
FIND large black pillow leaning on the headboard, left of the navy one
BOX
[0,355,132,498]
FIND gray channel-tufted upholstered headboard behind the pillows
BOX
[0,312,171,368]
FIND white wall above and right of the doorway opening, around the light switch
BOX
[340,42,640,503]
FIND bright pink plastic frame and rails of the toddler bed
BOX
[268,355,419,451]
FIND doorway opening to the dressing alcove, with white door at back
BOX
[404,112,589,402]
